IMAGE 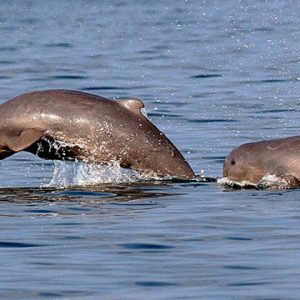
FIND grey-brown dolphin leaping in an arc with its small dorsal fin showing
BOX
[0,90,195,179]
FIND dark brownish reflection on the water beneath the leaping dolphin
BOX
[0,177,216,203]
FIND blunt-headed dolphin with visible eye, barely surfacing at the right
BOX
[223,136,300,187]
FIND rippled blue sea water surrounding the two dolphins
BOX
[0,0,300,299]
